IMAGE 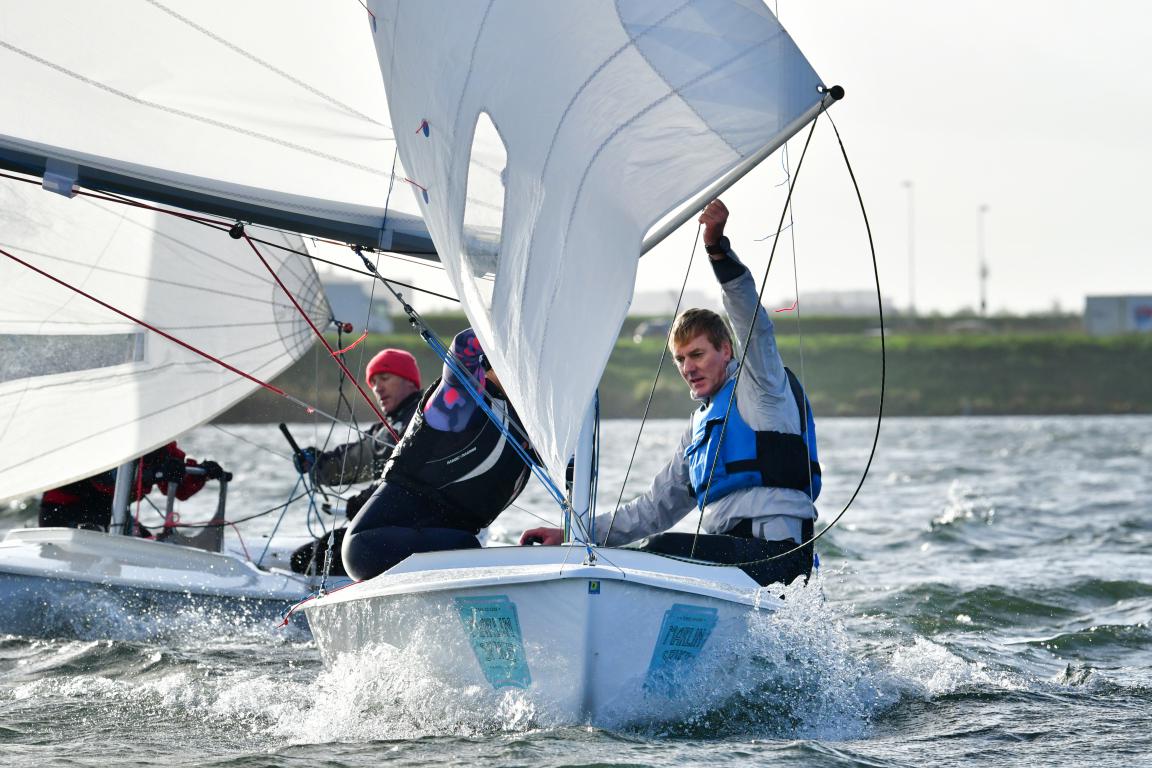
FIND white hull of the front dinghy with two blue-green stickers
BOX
[303,547,778,725]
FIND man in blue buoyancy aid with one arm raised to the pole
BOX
[521,200,820,584]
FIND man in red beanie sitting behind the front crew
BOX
[291,349,420,576]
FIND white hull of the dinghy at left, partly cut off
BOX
[0,529,327,636]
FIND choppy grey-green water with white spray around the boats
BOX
[0,417,1152,767]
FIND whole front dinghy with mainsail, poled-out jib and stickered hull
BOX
[0,0,835,723]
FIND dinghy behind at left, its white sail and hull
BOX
[0,180,340,634]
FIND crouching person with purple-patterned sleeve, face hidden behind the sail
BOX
[342,328,530,580]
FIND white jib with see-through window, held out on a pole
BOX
[369,0,821,478]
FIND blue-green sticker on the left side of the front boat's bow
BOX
[455,594,532,689]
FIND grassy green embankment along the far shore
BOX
[217,315,1152,423]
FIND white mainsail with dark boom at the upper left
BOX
[0,0,431,253]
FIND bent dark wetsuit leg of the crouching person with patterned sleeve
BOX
[342,482,480,580]
